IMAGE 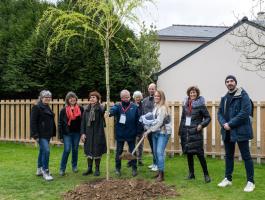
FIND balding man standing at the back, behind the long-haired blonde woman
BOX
[142,83,158,171]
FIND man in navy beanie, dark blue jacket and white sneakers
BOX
[218,75,255,192]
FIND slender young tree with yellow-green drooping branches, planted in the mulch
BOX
[37,0,151,180]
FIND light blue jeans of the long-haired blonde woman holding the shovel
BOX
[152,132,170,171]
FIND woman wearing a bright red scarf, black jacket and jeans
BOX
[58,92,84,176]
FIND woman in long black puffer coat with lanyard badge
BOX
[179,86,211,183]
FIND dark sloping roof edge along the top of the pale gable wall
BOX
[156,17,265,76]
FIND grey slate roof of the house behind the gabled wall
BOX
[158,24,229,41]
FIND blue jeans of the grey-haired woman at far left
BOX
[38,138,50,171]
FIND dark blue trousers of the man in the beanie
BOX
[224,140,254,183]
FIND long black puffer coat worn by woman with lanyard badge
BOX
[179,96,211,154]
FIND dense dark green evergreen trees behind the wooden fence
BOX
[0,0,140,101]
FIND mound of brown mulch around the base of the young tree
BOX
[63,179,179,200]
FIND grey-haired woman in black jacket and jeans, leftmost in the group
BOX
[30,90,56,181]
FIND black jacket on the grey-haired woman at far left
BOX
[30,102,56,139]
